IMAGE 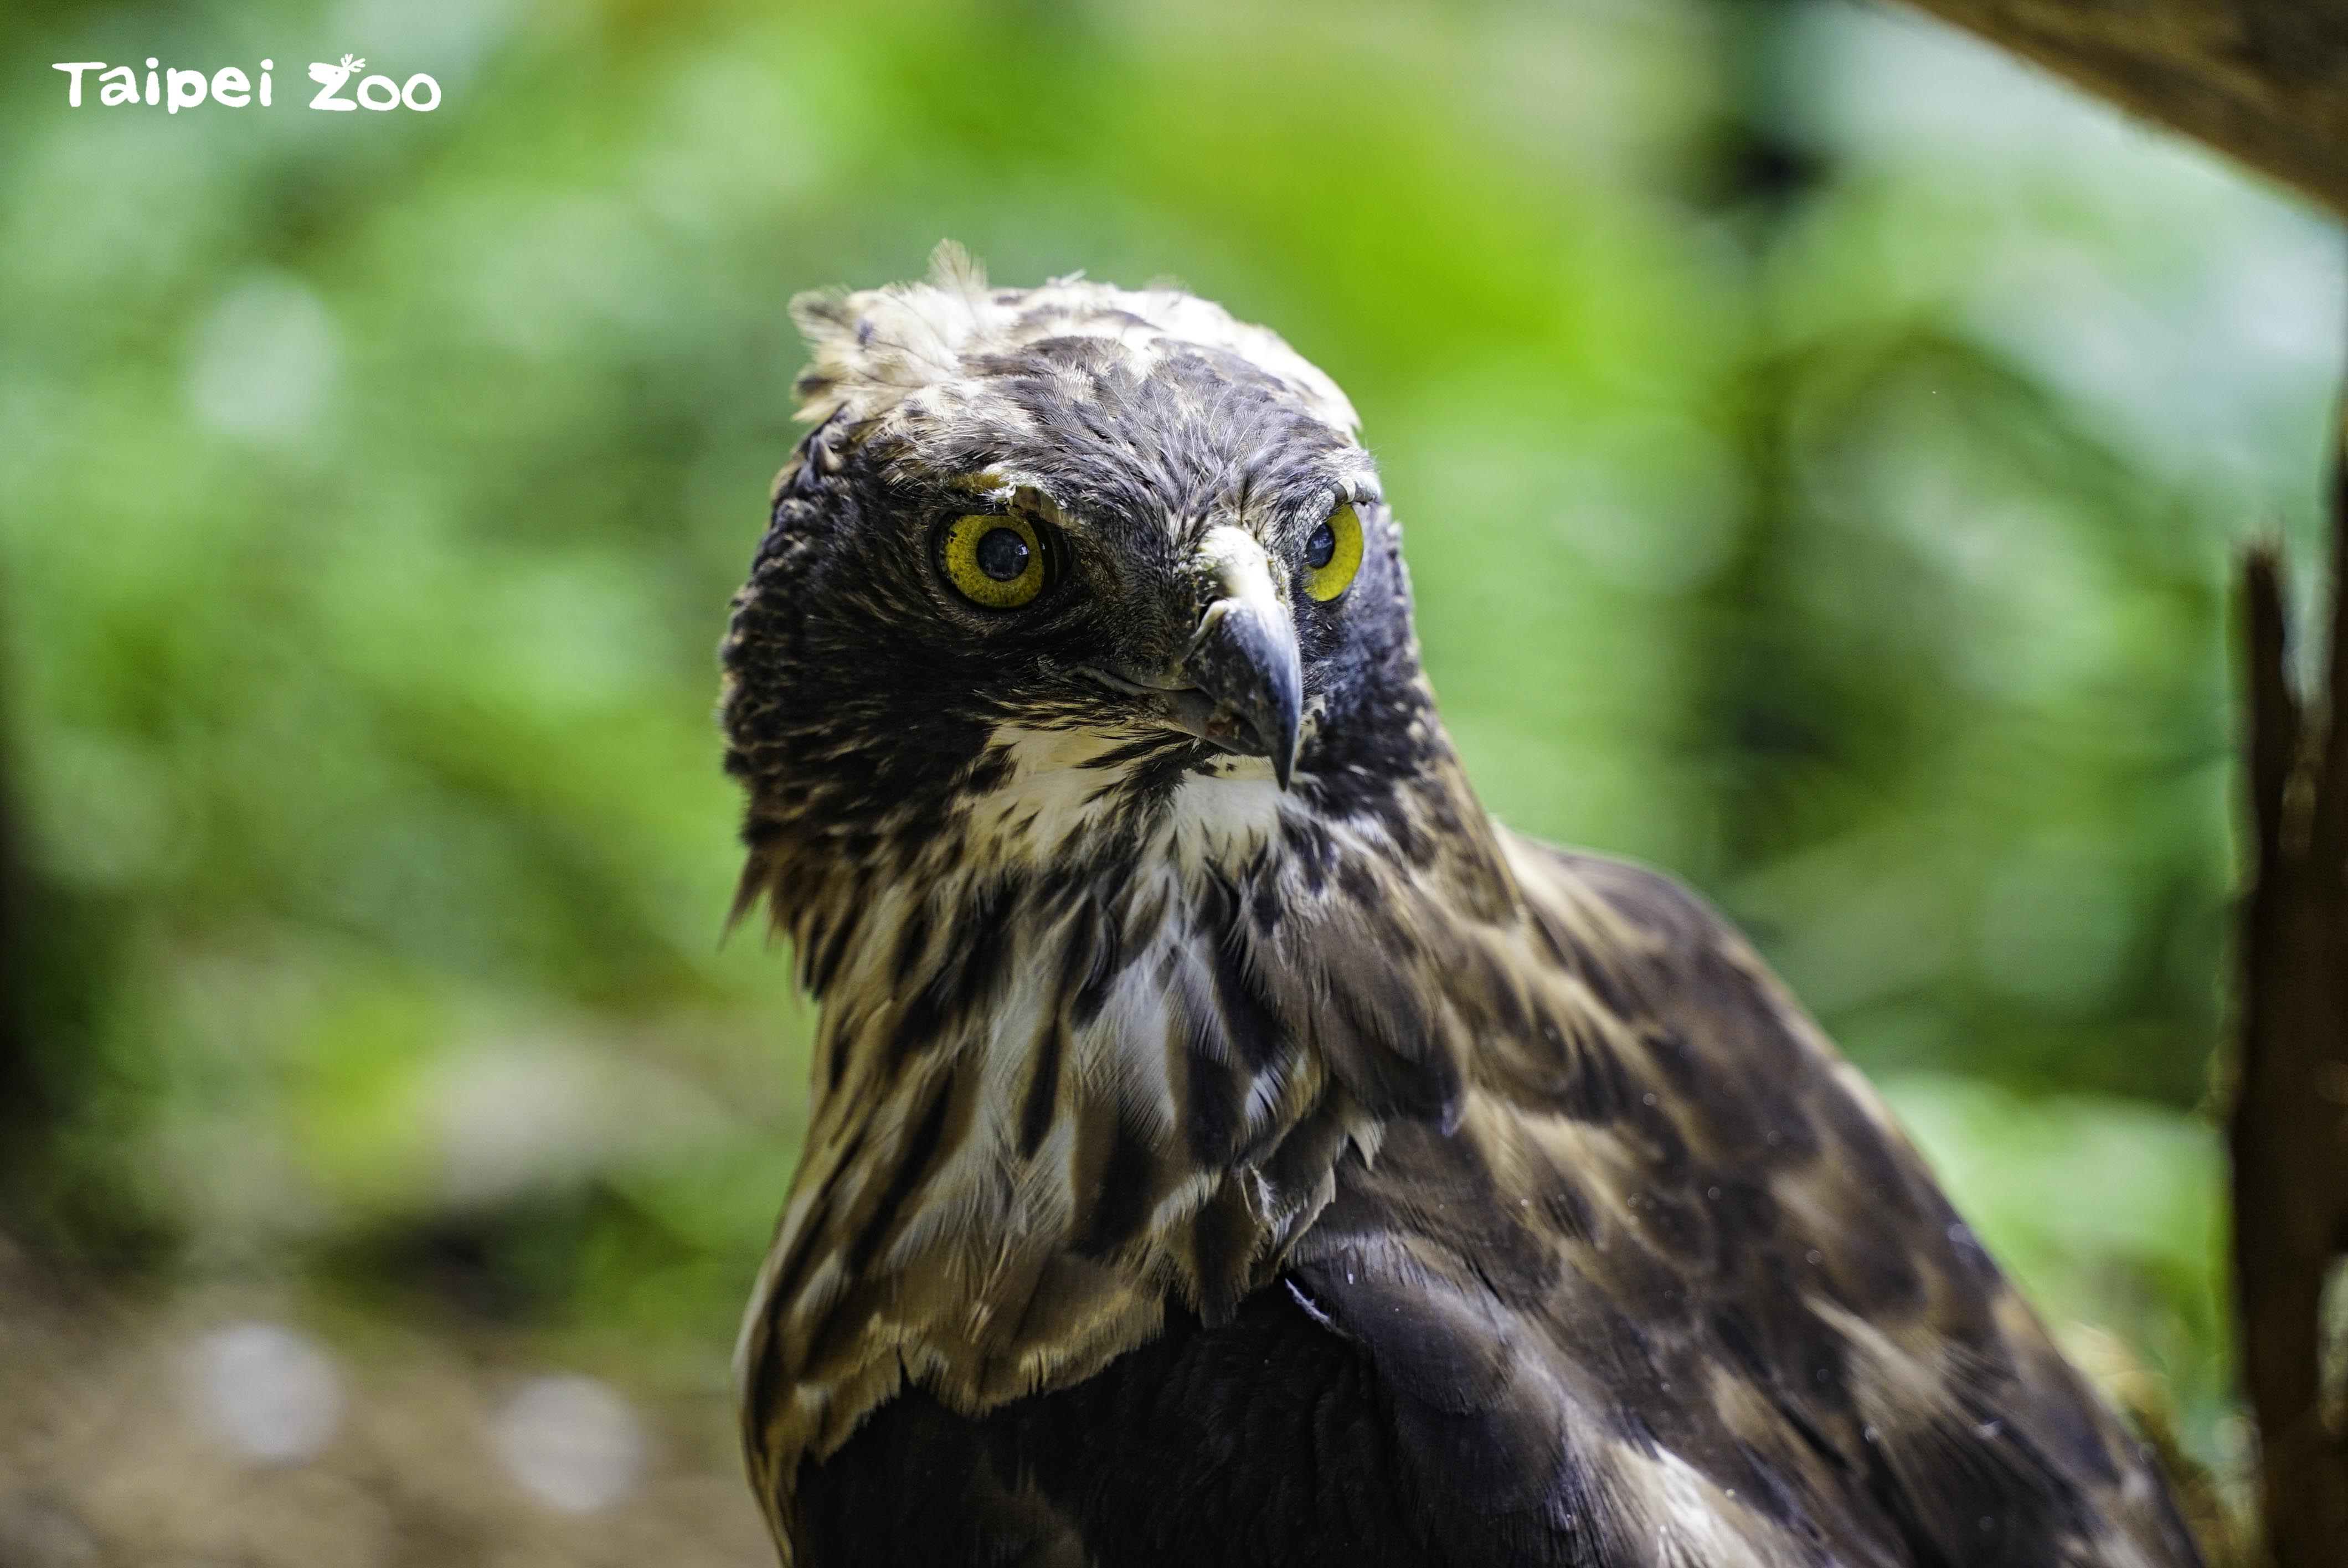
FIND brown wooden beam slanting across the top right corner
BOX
[1914,0,2348,216]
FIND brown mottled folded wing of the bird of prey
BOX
[1287,840,2200,1568]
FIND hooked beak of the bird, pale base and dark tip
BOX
[1181,528,1305,788]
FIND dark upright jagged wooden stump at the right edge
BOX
[2228,408,2348,1568]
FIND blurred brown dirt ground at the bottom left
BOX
[0,1239,775,1568]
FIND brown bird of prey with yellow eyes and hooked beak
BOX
[721,249,2200,1568]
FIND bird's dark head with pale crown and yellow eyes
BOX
[723,249,1439,943]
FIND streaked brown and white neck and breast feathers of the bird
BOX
[740,709,1519,1507]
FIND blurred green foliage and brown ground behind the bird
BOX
[0,0,2348,1566]
